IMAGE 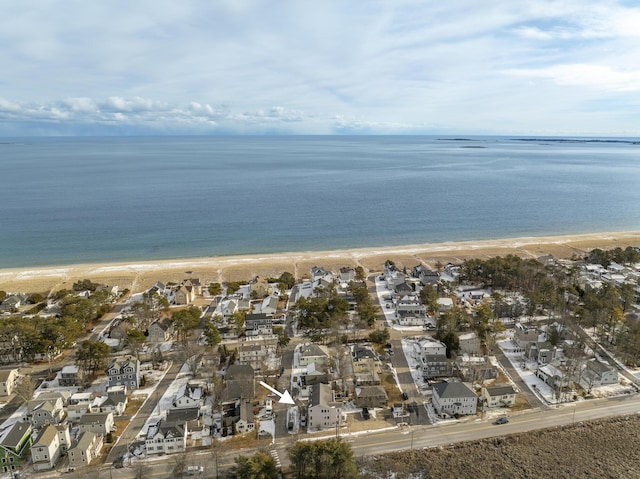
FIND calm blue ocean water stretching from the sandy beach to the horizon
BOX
[0,136,640,268]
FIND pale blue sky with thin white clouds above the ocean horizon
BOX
[0,0,640,137]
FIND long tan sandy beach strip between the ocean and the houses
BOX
[0,231,640,293]
